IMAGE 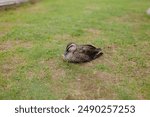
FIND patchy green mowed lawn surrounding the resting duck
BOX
[0,0,150,99]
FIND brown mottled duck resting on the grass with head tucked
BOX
[63,42,103,63]
